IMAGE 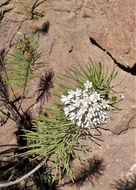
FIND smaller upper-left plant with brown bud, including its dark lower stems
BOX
[0,33,41,137]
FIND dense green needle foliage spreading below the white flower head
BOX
[21,110,95,183]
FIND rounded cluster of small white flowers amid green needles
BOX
[61,81,109,128]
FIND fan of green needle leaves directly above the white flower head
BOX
[62,60,118,106]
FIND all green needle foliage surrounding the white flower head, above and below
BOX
[18,62,121,180]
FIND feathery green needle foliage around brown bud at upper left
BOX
[7,33,41,87]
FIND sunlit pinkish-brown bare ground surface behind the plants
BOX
[0,0,136,190]
